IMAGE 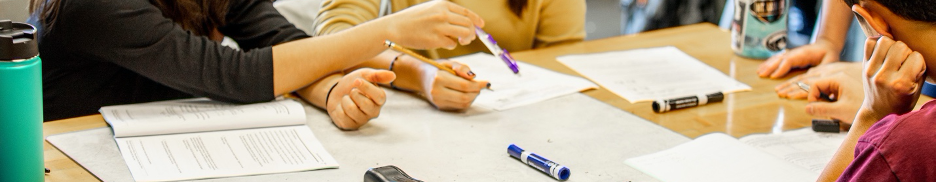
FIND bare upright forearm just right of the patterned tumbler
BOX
[814,0,854,59]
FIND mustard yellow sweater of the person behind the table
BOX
[314,0,585,58]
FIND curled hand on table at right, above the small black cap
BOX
[797,72,864,124]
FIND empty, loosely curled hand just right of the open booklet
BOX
[325,68,396,130]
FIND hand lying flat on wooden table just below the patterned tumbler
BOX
[757,41,838,79]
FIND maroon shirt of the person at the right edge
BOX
[838,101,936,181]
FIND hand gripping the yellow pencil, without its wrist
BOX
[420,61,490,111]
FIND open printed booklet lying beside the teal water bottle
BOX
[100,98,338,181]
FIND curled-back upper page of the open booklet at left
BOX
[100,98,305,137]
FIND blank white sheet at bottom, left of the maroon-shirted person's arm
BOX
[625,133,819,182]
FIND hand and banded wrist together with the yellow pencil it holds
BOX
[386,41,491,111]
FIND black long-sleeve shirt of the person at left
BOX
[31,0,308,121]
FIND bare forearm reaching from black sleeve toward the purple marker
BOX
[273,18,394,95]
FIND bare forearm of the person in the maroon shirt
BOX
[818,109,883,181]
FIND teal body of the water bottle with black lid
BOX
[0,56,45,181]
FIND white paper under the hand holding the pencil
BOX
[452,53,597,111]
